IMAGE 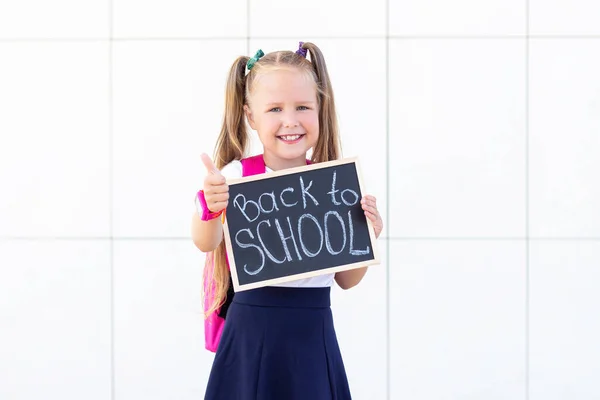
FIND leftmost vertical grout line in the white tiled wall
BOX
[108,0,117,400]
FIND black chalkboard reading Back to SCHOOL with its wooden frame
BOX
[224,158,379,291]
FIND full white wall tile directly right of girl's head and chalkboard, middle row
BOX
[388,39,526,237]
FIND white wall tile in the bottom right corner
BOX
[529,240,600,400]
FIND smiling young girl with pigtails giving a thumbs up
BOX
[192,42,383,400]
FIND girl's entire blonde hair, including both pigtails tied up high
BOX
[203,42,341,316]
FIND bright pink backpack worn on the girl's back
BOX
[202,154,266,353]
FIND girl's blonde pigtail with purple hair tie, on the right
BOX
[302,42,342,162]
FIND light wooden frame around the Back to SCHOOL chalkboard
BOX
[223,157,381,292]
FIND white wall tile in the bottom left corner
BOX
[0,240,112,400]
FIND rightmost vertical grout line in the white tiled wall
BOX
[525,0,530,400]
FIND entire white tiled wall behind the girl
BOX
[0,0,600,400]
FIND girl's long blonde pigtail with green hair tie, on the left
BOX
[202,56,249,317]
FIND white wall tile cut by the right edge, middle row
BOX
[529,38,600,238]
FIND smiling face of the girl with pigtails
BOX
[244,68,319,170]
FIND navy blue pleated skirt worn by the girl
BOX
[205,287,351,400]
